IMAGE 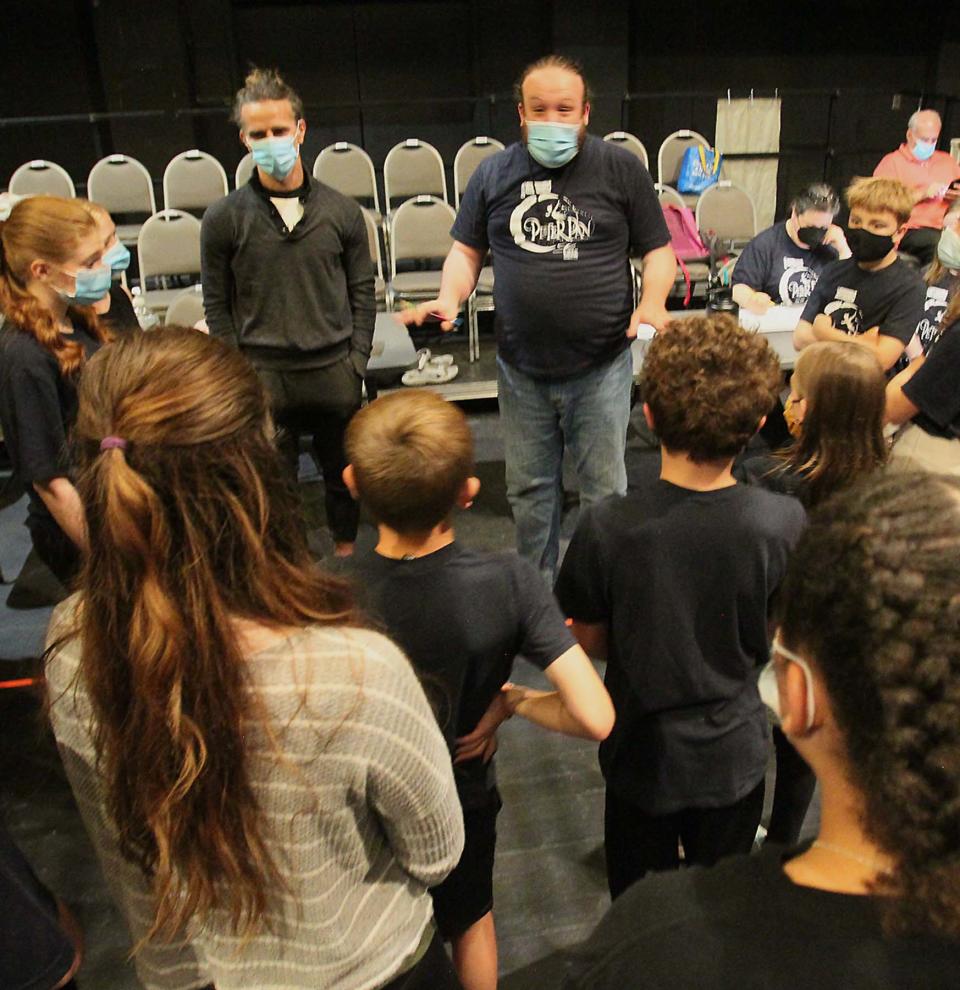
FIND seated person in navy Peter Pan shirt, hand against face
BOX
[732,182,850,316]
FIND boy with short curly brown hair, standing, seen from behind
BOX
[556,316,805,897]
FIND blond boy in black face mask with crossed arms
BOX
[793,178,925,371]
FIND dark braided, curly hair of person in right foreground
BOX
[778,473,960,938]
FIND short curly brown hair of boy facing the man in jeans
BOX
[641,315,781,463]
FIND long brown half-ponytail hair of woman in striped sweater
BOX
[68,327,355,938]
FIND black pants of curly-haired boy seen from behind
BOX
[604,780,763,898]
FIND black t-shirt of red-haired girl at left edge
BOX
[0,319,100,528]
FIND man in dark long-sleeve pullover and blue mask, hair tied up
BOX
[201,69,376,556]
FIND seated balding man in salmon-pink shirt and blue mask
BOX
[873,110,960,265]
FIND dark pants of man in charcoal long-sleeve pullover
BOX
[257,357,363,543]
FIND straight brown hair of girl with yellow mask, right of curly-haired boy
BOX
[782,340,887,507]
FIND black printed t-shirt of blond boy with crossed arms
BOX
[800,258,926,346]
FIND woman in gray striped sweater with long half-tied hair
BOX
[47,328,463,990]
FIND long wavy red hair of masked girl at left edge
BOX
[0,196,110,375]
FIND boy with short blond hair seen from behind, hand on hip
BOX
[344,390,613,990]
